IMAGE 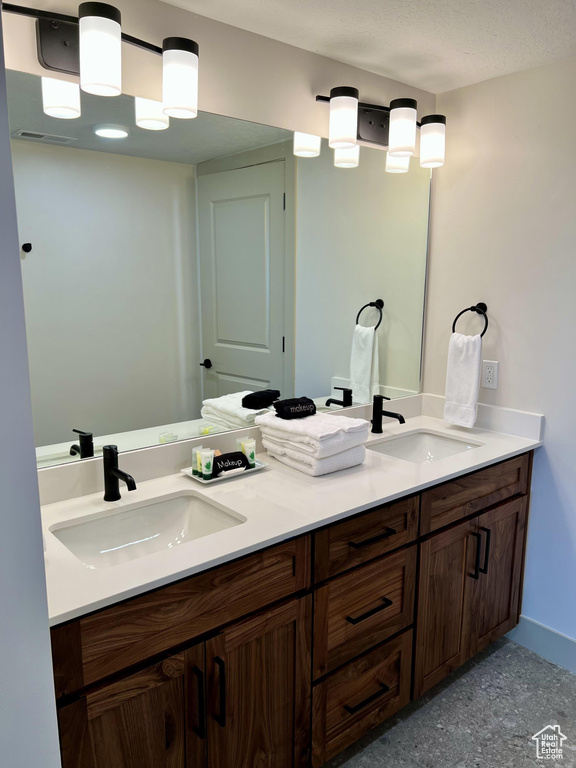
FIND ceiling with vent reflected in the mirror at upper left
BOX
[7,70,292,165]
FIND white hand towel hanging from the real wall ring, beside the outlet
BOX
[444,333,482,427]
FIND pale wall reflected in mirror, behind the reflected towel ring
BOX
[295,141,430,397]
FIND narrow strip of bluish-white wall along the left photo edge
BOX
[0,19,60,768]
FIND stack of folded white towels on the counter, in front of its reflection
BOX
[255,413,370,477]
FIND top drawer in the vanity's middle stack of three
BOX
[314,496,418,583]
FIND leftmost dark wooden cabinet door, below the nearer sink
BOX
[58,644,206,768]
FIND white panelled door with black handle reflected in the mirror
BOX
[198,162,285,398]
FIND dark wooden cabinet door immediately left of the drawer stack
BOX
[206,596,312,768]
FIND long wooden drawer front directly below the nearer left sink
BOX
[52,536,310,696]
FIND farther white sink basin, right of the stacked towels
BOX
[366,430,483,464]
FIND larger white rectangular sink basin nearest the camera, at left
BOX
[50,491,246,568]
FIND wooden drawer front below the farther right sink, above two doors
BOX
[420,454,530,536]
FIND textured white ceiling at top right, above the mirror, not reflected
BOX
[161,0,576,93]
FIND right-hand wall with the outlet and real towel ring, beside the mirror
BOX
[424,59,576,638]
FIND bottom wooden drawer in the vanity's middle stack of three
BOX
[312,630,412,768]
